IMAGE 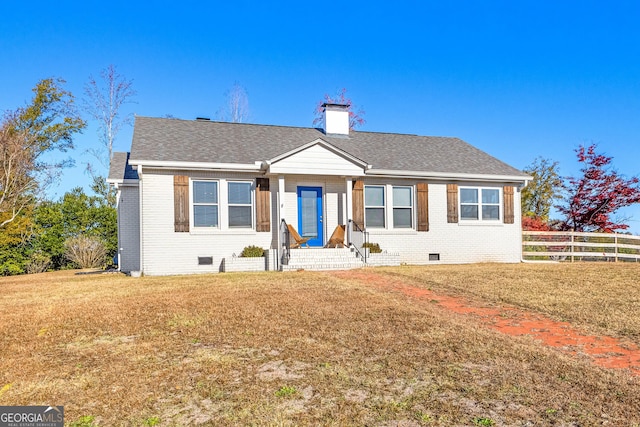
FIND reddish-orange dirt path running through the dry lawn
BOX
[335,270,640,376]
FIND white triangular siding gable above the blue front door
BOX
[269,144,364,176]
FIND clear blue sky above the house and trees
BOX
[0,0,640,233]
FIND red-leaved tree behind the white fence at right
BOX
[556,144,640,233]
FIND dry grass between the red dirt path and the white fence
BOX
[376,263,640,345]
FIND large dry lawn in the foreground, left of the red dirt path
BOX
[0,266,640,426]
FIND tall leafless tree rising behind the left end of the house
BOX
[84,65,137,171]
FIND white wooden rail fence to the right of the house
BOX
[522,231,640,262]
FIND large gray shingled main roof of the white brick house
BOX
[131,117,526,178]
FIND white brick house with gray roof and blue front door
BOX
[108,105,529,275]
